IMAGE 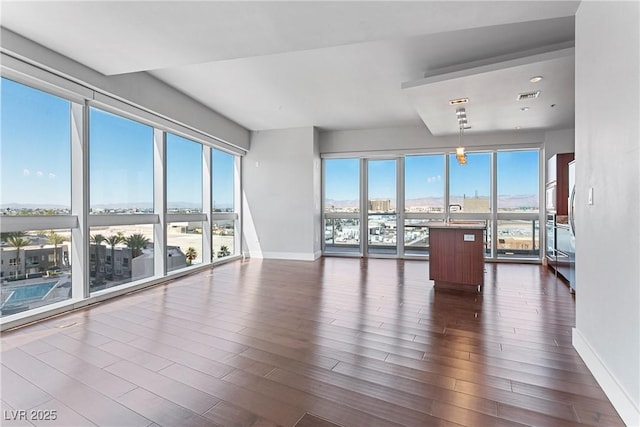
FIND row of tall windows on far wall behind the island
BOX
[324,148,540,260]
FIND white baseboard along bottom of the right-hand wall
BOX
[572,328,640,427]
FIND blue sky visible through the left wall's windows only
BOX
[0,78,233,211]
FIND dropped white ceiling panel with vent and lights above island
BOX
[403,45,575,136]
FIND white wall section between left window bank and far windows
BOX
[242,127,321,260]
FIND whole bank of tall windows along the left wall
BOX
[0,66,242,326]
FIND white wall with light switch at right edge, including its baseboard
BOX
[573,1,640,426]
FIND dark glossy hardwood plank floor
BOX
[1,258,623,427]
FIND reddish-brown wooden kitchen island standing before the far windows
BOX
[429,222,486,292]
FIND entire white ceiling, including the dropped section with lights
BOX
[0,0,579,135]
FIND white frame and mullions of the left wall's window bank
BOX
[0,57,246,330]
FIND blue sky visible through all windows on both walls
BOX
[0,78,538,211]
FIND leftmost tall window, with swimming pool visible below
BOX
[0,78,74,316]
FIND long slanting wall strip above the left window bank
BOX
[0,28,249,150]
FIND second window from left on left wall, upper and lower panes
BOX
[88,108,155,292]
